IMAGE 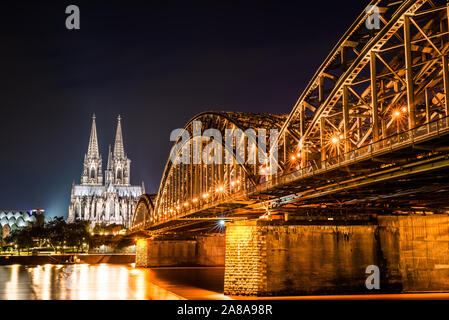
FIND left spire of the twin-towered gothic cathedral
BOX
[81,114,103,185]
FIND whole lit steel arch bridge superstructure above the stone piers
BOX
[133,0,449,235]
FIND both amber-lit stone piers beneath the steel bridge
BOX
[136,214,449,296]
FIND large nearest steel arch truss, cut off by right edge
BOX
[272,0,449,173]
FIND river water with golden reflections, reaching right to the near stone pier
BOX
[0,264,226,300]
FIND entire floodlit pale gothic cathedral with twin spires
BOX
[67,115,145,227]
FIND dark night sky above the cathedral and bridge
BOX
[0,0,368,217]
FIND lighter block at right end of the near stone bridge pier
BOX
[378,214,449,292]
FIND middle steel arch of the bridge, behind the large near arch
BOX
[142,112,286,228]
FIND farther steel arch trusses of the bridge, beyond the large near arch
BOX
[134,112,286,227]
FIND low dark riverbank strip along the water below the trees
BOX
[0,253,136,265]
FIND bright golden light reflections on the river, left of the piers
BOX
[0,264,186,300]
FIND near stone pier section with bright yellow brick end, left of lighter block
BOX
[224,218,380,296]
